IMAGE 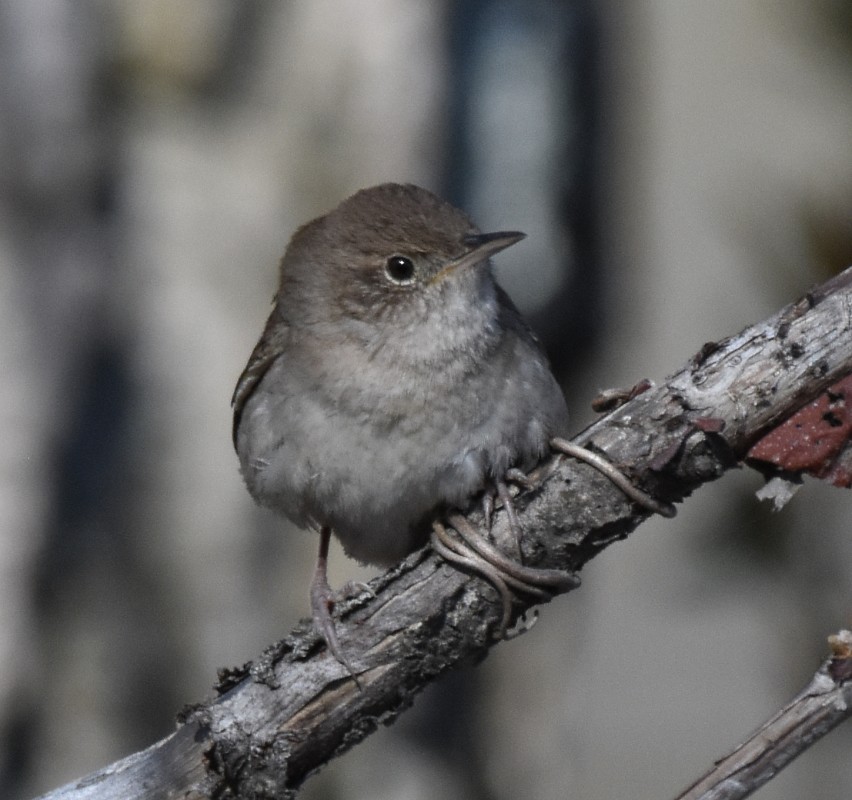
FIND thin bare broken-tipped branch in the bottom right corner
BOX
[675,630,852,800]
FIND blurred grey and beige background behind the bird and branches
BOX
[0,0,852,800]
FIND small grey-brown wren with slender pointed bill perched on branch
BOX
[233,183,580,663]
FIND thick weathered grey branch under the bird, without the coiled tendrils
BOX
[36,269,852,800]
